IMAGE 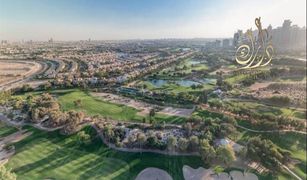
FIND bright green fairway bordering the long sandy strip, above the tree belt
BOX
[13,89,186,124]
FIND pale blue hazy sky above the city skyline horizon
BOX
[0,0,306,41]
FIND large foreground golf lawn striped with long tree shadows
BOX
[7,127,203,180]
